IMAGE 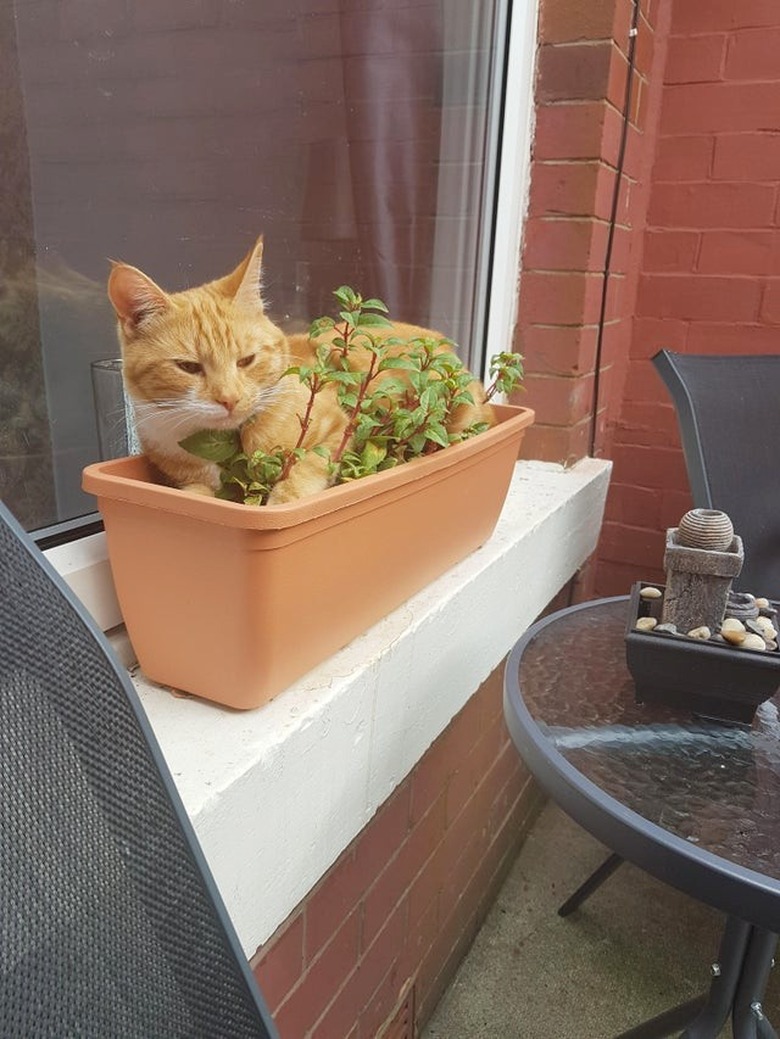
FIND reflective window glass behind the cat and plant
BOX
[0,0,506,529]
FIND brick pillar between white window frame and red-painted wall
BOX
[515,0,658,471]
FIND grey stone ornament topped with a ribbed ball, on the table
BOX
[662,509,745,633]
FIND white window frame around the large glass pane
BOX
[46,0,538,631]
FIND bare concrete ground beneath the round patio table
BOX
[422,804,780,1039]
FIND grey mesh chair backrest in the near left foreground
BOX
[0,505,276,1039]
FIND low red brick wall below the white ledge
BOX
[252,668,540,1039]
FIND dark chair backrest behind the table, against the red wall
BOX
[652,350,780,598]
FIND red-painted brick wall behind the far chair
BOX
[596,0,780,594]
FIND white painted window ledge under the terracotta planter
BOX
[123,459,610,956]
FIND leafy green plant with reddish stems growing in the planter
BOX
[181,286,523,505]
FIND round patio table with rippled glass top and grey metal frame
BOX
[504,596,780,1039]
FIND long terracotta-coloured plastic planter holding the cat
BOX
[83,406,534,709]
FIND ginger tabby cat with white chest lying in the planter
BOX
[108,238,494,504]
